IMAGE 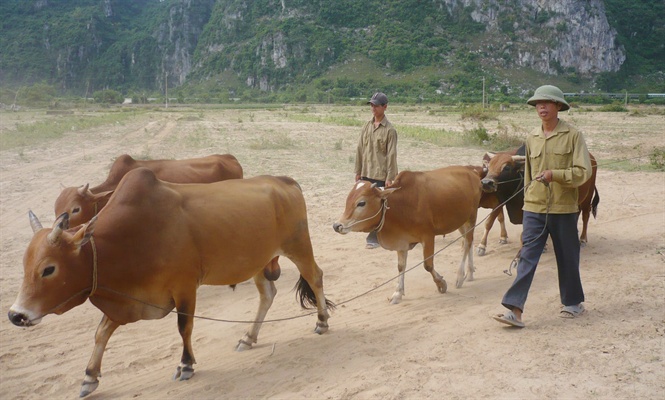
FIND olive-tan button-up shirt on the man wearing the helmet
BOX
[523,120,591,214]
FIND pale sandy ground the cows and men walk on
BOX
[0,106,665,399]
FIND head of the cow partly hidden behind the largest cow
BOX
[55,184,113,226]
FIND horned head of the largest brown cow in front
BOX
[9,211,97,326]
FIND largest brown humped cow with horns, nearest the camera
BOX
[9,168,333,396]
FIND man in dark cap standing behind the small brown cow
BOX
[355,92,397,249]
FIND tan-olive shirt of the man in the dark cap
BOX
[355,116,397,181]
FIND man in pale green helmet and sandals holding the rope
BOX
[494,85,591,328]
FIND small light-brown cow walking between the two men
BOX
[333,166,482,304]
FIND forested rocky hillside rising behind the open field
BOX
[0,0,665,101]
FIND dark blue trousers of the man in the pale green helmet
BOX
[501,211,584,311]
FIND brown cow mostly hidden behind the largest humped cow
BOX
[55,154,243,226]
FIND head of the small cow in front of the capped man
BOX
[333,181,399,234]
